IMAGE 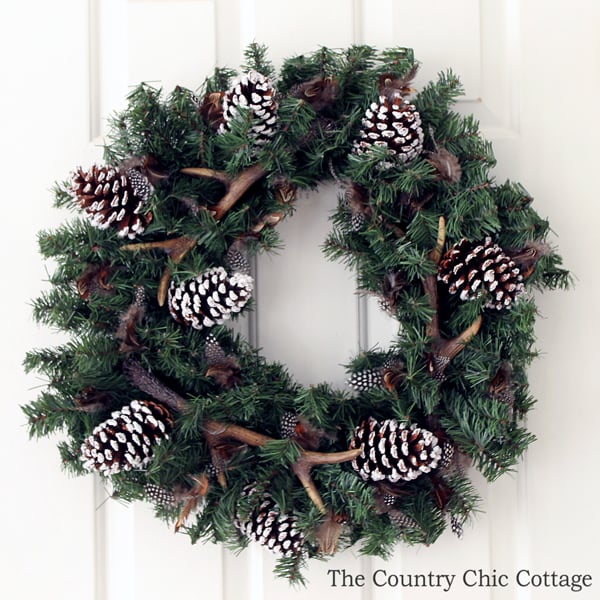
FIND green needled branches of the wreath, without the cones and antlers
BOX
[23,45,569,581]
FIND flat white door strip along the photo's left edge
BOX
[0,2,95,600]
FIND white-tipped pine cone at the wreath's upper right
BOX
[353,94,424,169]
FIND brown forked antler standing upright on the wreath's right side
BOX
[423,217,483,380]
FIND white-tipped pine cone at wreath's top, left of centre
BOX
[219,71,277,146]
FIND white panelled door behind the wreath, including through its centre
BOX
[0,0,600,600]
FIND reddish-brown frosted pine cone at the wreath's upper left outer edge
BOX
[71,165,153,239]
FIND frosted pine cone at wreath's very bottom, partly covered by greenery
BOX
[234,486,304,556]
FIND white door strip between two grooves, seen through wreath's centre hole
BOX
[254,183,358,386]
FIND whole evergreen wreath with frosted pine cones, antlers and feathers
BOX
[24,44,570,582]
